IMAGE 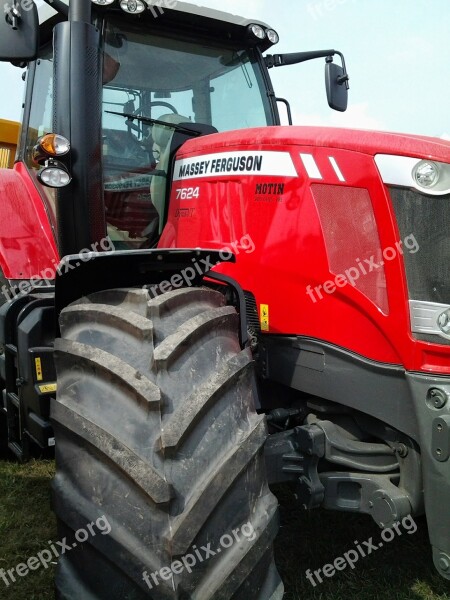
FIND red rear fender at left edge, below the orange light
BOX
[0,163,59,279]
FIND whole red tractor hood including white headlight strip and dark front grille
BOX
[167,126,450,374]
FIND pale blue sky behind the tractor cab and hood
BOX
[0,0,450,137]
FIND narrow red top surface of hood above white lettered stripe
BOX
[178,126,450,162]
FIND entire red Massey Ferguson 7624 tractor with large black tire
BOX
[0,0,450,600]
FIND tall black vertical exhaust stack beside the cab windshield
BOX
[53,21,106,256]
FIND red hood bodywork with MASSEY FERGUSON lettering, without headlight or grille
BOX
[159,127,450,374]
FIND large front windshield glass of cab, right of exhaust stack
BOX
[103,19,274,247]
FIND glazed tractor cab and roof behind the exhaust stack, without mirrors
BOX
[15,2,279,249]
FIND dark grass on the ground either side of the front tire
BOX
[0,461,450,600]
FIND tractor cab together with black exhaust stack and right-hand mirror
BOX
[0,0,348,255]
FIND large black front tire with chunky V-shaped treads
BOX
[52,288,283,600]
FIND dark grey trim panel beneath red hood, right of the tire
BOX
[258,335,419,442]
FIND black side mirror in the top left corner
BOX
[0,0,39,62]
